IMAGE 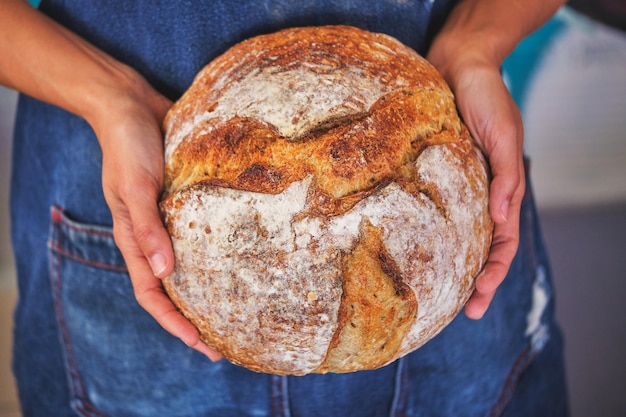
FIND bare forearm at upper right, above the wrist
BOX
[428,0,565,75]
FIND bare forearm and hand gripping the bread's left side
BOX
[0,0,220,360]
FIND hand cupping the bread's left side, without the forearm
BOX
[92,76,221,361]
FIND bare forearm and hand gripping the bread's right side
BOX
[427,0,565,319]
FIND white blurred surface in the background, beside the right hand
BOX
[523,11,626,207]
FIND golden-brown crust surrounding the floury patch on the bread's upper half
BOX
[165,26,460,202]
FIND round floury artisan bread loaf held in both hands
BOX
[161,26,493,375]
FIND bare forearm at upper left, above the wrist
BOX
[0,0,145,132]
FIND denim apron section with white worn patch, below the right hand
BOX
[398,167,568,417]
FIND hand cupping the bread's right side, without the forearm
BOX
[428,46,525,319]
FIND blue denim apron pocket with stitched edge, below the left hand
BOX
[48,207,270,417]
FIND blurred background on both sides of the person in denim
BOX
[0,0,626,417]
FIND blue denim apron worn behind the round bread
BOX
[11,0,565,417]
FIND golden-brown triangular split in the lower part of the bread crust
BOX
[315,220,418,372]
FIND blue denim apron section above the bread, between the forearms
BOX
[40,0,456,99]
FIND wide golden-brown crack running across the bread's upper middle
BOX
[166,90,461,215]
